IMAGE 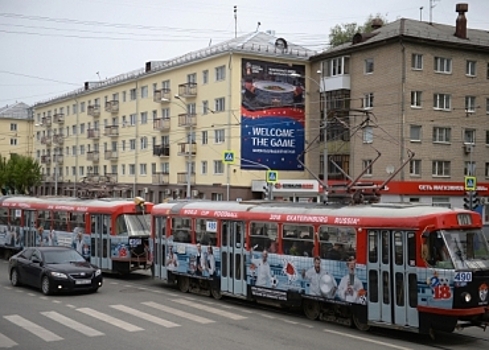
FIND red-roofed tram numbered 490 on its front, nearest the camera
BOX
[152,201,489,333]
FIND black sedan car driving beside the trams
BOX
[9,247,103,295]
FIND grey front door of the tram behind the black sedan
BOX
[89,214,112,270]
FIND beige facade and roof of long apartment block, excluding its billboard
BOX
[34,33,317,202]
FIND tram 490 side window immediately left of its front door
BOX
[319,226,356,261]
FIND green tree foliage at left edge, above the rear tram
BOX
[0,154,42,194]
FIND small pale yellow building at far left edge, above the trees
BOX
[0,102,33,159]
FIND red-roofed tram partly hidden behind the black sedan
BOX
[0,196,153,274]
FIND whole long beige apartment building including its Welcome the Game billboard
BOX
[34,32,318,202]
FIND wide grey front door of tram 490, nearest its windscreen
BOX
[367,230,419,327]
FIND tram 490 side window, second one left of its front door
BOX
[282,225,314,256]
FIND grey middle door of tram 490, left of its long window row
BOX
[221,221,246,296]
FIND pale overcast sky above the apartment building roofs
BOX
[0,0,489,107]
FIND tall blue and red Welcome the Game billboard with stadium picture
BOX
[240,59,305,171]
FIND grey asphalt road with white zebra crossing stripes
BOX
[0,260,489,350]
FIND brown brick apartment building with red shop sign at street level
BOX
[311,4,489,216]
